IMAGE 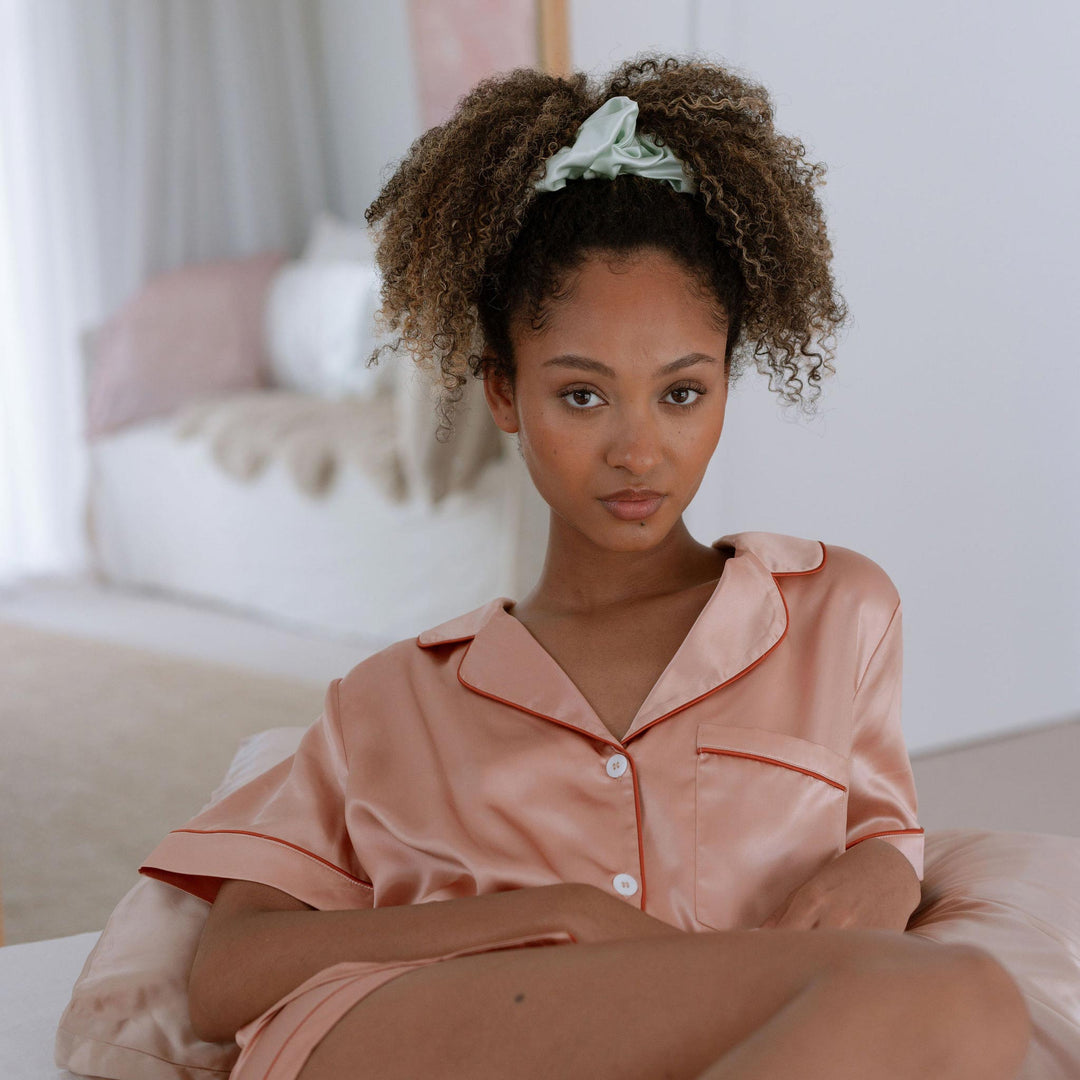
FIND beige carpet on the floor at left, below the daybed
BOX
[0,622,326,944]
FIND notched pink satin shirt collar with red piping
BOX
[417,532,825,744]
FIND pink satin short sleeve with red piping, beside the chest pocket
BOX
[847,600,923,881]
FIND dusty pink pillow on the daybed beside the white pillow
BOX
[86,252,287,438]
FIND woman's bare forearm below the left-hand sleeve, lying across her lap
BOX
[188,883,590,1041]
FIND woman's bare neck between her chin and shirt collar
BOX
[515,514,725,615]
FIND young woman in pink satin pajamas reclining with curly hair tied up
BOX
[141,57,1029,1080]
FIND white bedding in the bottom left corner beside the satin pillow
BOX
[0,930,99,1080]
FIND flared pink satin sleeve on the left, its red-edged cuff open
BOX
[139,679,374,910]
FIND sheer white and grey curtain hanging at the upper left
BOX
[0,0,337,585]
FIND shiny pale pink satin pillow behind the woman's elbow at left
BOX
[55,727,306,1080]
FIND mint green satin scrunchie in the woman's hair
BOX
[534,95,698,194]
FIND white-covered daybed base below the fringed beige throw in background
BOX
[91,419,546,640]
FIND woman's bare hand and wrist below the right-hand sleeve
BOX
[761,837,921,930]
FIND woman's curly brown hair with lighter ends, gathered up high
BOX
[364,53,847,435]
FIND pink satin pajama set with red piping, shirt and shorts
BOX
[140,532,923,1080]
